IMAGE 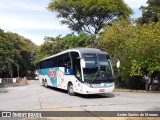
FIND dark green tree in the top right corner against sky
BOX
[138,0,160,24]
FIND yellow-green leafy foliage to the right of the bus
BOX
[97,20,160,88]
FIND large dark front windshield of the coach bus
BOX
[83,54,113,83]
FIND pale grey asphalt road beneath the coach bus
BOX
[0,81,160,111]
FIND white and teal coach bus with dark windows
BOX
[39,48,114,95]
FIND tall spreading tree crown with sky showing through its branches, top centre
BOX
[48,0,132,34]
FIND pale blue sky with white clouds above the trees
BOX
[0,0,147,45]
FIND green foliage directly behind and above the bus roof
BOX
[34,32,93,63]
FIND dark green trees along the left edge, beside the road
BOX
[0,30,36,77]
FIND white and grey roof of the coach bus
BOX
[42,47,108,61]
